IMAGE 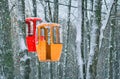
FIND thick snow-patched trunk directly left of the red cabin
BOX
[9,0,31,79]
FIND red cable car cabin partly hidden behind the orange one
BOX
[25,17,42,52]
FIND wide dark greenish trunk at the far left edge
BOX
[0,0,14,79]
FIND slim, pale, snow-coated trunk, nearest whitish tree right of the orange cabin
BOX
[76,0,84,79]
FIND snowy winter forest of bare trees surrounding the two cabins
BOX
[0,0,120,79]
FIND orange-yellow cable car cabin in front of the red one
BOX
[36,23,62,62]
